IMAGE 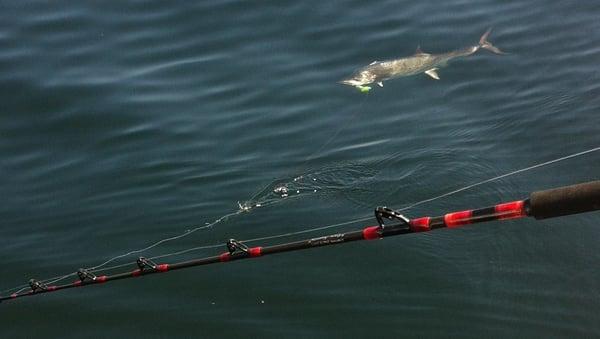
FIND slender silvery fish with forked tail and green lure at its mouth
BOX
[339,28,506,91]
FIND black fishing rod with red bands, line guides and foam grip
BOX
[0,180,600,302]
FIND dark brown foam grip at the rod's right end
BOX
[528,180,600,219]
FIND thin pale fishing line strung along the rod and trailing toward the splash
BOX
[1,146,600,294]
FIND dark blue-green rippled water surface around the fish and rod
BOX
[0,0,600,338]
